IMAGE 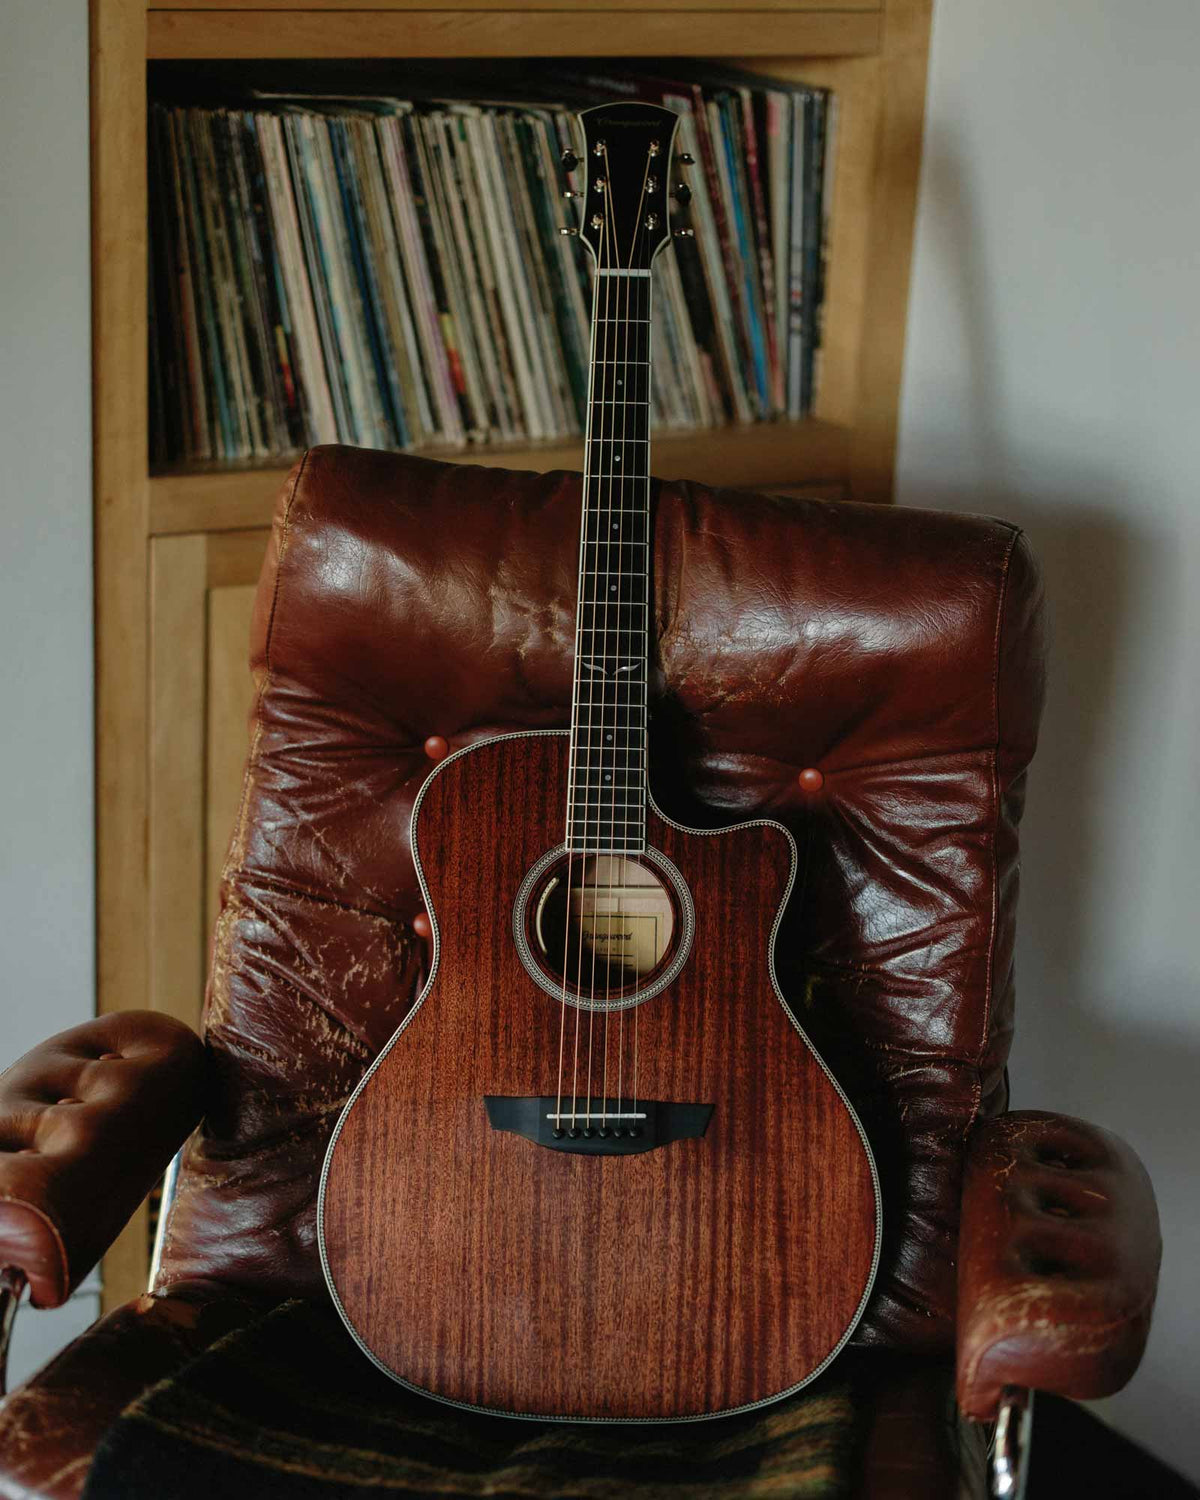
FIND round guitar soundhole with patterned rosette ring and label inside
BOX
[513,845,696,1011]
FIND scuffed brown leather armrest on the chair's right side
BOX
[957,1110,1163,1421]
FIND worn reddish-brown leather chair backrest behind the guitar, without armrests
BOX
[159,447,1044,1349]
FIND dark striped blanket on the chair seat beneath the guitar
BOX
[84,1302,869,1500]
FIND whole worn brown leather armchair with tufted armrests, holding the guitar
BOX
[0,449,1160,1500]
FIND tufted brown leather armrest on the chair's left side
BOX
[0,1011,204,1308]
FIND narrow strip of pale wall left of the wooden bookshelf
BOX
[0,0,98,1383]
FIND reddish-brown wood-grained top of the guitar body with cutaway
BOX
[323,735,876,1419]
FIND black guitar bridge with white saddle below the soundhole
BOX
[483,1094,714,1157]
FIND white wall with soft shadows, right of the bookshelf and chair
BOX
[899,0,1200,1478]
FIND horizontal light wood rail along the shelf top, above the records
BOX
[146,9,882,60]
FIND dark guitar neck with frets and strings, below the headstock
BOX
[567,270,651,852]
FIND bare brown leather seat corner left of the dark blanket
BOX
[0,1289,257,1500]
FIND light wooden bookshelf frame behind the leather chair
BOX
[90,0,932,1307]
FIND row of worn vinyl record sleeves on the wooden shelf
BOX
[150,75,836,465]
